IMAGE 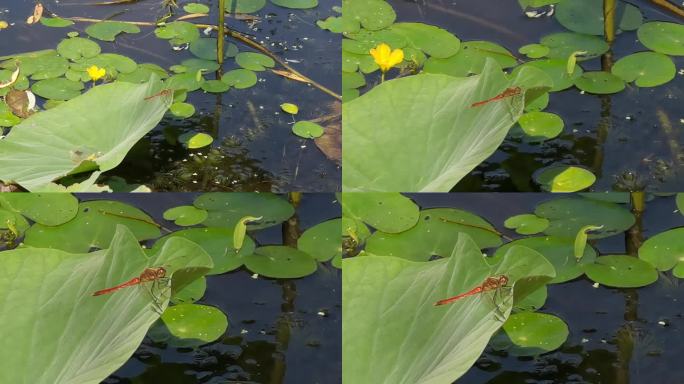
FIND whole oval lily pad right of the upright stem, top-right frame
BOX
[611,50,684,87]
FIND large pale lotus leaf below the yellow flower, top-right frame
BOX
[342,60,545,192]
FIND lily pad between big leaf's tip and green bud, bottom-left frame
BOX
[152,228,256,275]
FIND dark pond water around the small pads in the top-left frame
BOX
[0,0,341,192]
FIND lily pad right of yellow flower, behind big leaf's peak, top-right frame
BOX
[423,41,518,77]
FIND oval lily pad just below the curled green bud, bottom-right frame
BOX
[584,255,658,288]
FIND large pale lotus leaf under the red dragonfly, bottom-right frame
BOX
[342,234,553,384]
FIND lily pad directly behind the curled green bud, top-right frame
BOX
[540,32,610,61]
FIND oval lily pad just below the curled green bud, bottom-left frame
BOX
[245,245,318,279]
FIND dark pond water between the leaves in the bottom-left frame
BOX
[71,193,342,384]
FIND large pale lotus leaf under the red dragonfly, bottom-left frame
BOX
[0,226,211,384]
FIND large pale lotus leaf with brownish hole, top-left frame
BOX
[0,80,171,191]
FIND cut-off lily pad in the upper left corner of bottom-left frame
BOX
[0,193,78,226]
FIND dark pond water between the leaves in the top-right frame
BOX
[389,0,684,192]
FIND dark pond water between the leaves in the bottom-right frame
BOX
[410,193,684,384]
